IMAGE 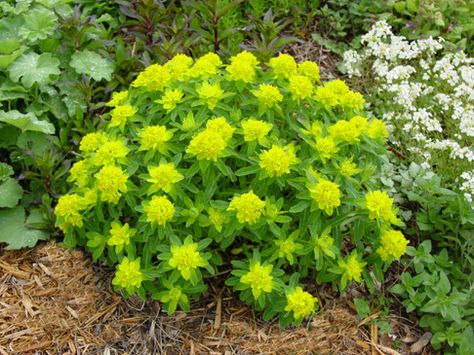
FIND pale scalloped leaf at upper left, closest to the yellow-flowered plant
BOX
[69,50,114,81]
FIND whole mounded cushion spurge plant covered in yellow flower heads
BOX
[56,52,408,324]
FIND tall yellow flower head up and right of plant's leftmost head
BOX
[96,165,128,204]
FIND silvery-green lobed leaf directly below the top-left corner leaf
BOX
[8,52,61,88]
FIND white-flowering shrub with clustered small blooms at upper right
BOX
[344,21,474,206]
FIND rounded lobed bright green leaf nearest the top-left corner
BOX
[19,7,58,42]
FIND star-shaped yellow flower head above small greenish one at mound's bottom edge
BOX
[168,243,207,280]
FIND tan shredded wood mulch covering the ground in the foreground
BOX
[0,242,430,355]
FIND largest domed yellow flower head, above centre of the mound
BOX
[186,129,227,161]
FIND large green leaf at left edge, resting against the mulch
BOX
[0,206,48,249]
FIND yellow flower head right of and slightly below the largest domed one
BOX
[258,145,298,176]
